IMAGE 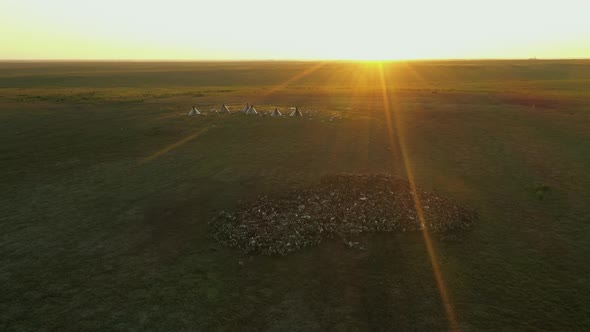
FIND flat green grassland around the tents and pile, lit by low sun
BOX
[0,60,590,331]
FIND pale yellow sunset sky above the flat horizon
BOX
[0,0,590,60]
